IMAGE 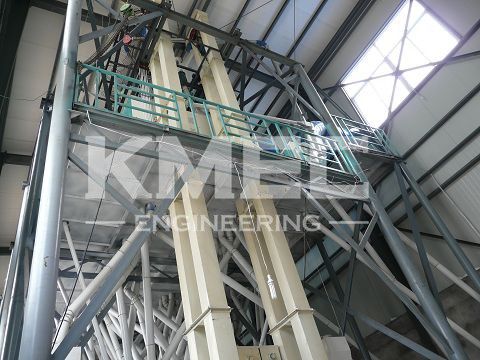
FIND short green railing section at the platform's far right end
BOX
[332,115,396,156]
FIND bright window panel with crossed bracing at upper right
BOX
[342,0,459,127]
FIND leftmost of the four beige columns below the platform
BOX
[169,199,209,360]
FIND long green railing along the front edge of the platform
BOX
[75,64,360,175]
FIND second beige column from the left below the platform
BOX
[181,179,238,360]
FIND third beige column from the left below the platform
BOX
[236,200,301,360]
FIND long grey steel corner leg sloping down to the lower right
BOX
[295,65,467,359]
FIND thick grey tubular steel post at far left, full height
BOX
[19,0,82,360]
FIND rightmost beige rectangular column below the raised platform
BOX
[253,192,327,360]
